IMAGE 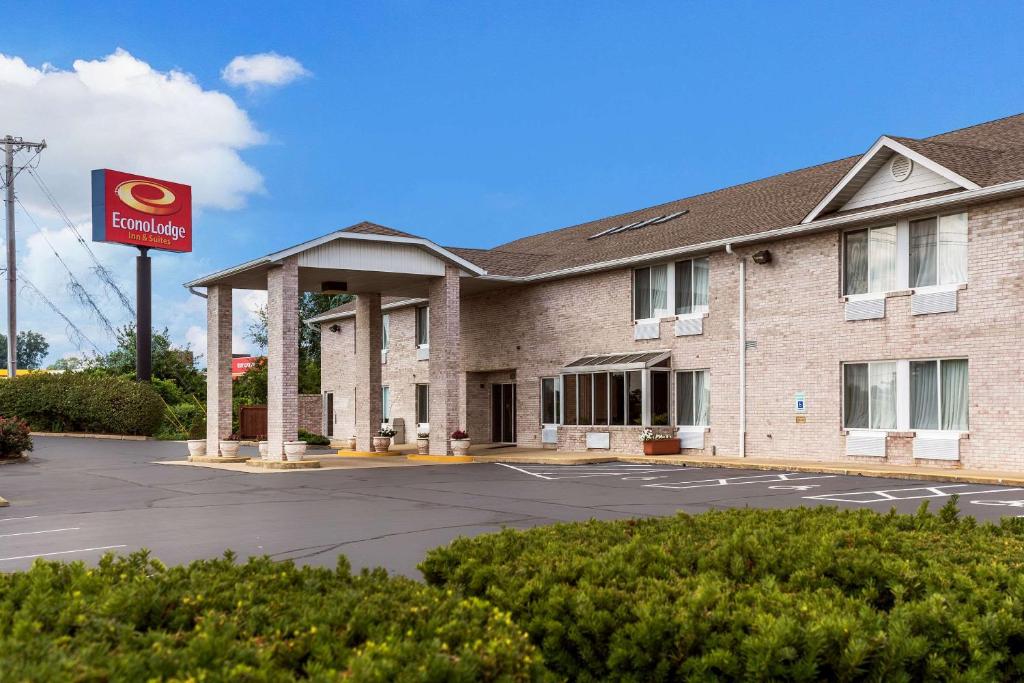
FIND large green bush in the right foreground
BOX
[421,505,1024,681]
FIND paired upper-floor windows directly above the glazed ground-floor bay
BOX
[633,257,709,321]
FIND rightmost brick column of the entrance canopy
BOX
[429,265,466,456]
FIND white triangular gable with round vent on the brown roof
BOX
[802,135,979,223]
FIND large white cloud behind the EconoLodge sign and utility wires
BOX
[0,49,264,358]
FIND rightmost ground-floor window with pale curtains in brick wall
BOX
[910,358,968,431]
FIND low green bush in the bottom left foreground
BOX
[0,552,548,682]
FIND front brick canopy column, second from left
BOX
[266,256,299,460]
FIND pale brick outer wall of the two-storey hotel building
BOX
[323,194,1024,469]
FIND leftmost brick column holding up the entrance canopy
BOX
[206,285,231,456]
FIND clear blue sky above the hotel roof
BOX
[0,1,1024,360]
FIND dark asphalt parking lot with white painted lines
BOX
[0,437,1024,577]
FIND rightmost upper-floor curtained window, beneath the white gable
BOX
[910,213,967,287]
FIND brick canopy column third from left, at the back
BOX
[355,294,384,452]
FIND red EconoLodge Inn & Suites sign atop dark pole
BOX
[92,169,191,252]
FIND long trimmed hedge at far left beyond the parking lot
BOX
[0,373,164,436]
